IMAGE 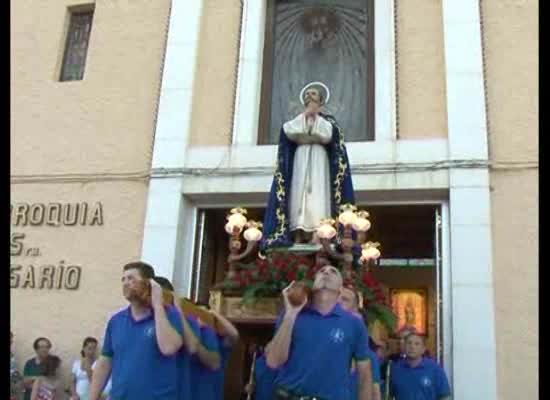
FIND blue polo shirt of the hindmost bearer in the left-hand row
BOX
[191,326,220,400]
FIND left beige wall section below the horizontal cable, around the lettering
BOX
[10,182,147,386]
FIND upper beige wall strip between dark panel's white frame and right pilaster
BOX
[395,0,447,139]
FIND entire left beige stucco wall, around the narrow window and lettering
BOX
[10,0,171,388]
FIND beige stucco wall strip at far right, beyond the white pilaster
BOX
[482,0,539,400]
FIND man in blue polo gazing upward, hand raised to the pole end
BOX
[266,265,372,400]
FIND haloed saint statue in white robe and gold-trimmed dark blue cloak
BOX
[261,82,354,249]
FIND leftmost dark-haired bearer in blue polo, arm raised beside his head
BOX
[90,262,183,400]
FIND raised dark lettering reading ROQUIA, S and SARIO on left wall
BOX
[10,202,103,290]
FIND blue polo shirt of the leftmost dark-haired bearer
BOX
[102,306,183,400]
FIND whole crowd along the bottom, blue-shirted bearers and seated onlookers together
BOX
[10,262,451,400]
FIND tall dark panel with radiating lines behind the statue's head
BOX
[260,0,374,143]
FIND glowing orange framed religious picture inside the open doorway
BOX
[390,289,428,335]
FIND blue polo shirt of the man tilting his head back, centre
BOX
[275,304,368,400]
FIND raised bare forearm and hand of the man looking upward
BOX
[265,281,307,369]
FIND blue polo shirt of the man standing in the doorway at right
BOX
[390,358,451,400]
